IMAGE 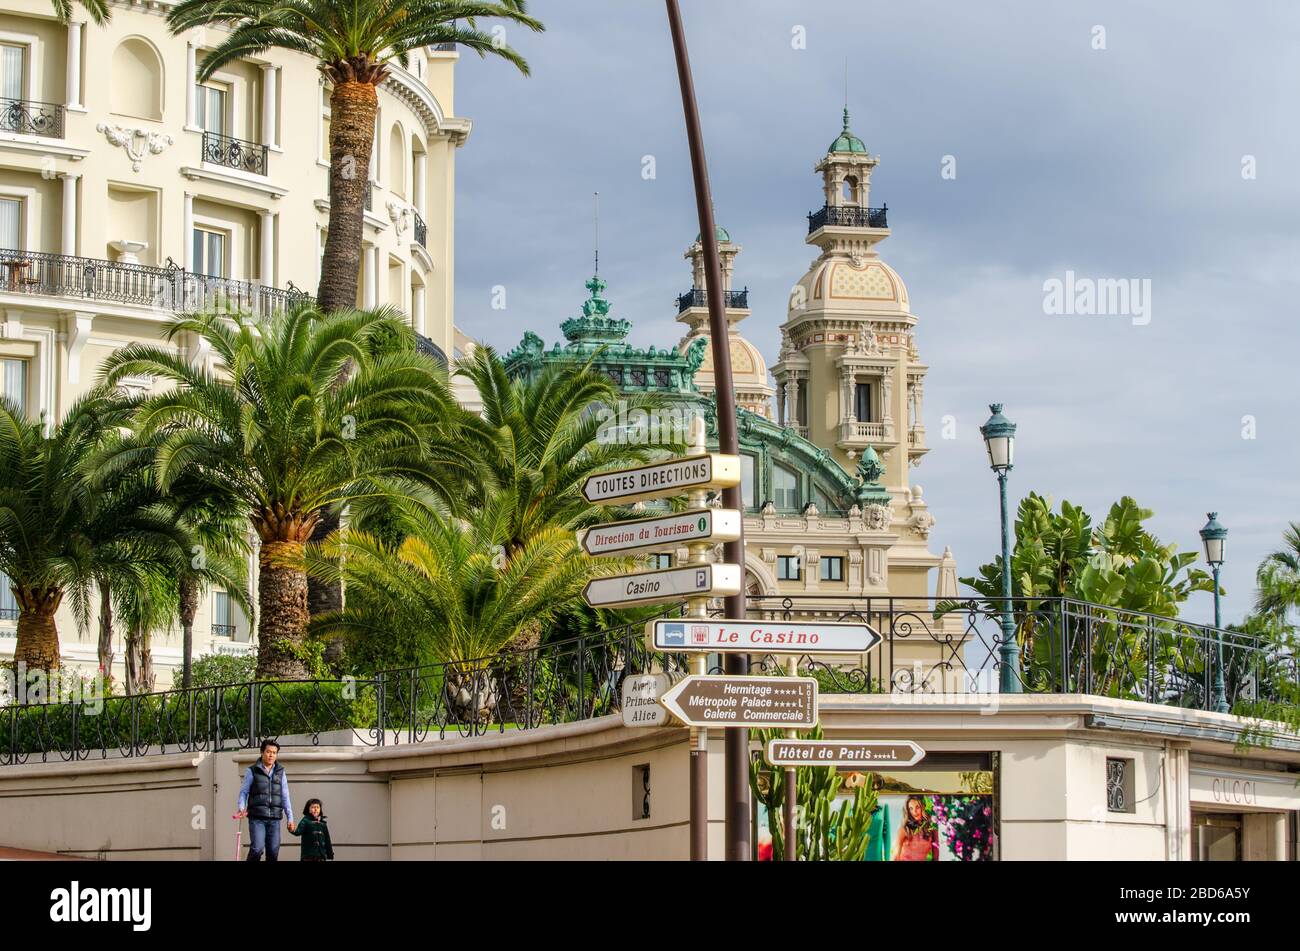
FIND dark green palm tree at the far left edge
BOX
[0,388,178,673]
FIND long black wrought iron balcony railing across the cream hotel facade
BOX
[0,248,311,317]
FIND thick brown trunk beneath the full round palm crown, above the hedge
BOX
[257,540,309,679]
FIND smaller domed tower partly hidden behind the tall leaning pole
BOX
[677,225,772,420]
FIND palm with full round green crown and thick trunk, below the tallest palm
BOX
[103,304,465,678]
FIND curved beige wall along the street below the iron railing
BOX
[0,695,1300,861]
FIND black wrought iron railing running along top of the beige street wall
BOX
[0,594,1300,765]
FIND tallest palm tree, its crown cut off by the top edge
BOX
[168,0,543,312]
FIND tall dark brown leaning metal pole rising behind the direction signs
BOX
[664,0,753,861]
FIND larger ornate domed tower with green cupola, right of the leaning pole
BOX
[772,108,927,504]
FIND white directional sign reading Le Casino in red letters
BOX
[646,617,880,653]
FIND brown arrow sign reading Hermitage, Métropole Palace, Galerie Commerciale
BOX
[659,674,816,730]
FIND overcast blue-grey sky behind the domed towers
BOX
[456,0,1300,620]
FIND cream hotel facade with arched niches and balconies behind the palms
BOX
[0,0,471,687]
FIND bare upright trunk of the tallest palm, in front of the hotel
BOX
[316,82,378,313]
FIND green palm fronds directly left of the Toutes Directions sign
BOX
[458,347,684,556]
